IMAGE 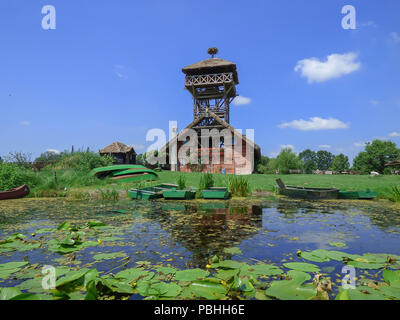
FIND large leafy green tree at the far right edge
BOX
[353,140,400,173]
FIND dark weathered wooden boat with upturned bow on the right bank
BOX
[276,179,339,200]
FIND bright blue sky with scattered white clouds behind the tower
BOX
[0,0,400,158]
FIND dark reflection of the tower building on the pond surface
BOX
[144,203,262,267]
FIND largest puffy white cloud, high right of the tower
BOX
[294,52,361,83]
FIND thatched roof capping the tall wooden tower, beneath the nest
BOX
[182,58,239,84]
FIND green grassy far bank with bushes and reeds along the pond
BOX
[0,151,400,202]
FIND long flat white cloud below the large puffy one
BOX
[278,117,349,131]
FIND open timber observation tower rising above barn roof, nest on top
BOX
[182,48,239,127]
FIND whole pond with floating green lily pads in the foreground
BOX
[0,199,400,299]
